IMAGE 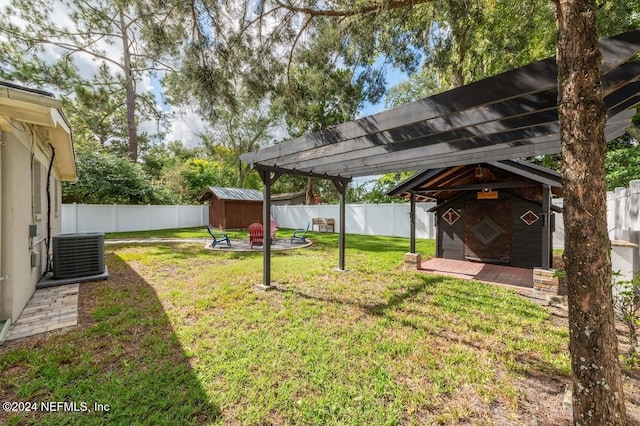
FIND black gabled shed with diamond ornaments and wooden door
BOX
[388,160,562,268]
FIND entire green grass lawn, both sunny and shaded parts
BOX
[0,235,570,425]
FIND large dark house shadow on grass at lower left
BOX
[0,254,221,425]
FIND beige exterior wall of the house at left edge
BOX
[0,125,61,321]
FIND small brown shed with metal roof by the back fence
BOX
[199,186,262,229]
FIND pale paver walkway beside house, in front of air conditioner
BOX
[5,283,80,341]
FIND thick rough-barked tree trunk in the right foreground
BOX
[556,0,626,425]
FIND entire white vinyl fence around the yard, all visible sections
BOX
[62,180,640,248]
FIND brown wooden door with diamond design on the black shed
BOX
[464,200,511,264]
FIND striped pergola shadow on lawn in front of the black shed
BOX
[276,274,568,379]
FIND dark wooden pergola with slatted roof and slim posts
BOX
[240,29,640,288]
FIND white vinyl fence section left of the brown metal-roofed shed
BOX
[62,204,209,234]
